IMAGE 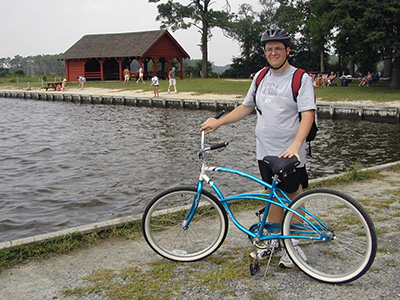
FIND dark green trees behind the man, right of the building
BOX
[149,0,400,88]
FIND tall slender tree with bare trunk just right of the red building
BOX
[149,0,232,78]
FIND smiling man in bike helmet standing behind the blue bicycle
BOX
[200,28,316,267]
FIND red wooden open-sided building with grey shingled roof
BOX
[59,30,189,81]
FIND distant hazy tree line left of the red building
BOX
[0,54,65,77]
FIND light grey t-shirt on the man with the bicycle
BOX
[243,66,317,167]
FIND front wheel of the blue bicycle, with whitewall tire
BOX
[142,187,228,261]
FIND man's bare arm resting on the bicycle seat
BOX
[279,110,315,161]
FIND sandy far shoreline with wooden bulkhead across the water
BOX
[0,88,400,124]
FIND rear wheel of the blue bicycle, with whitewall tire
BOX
[282,189,377,283]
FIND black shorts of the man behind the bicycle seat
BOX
[258,160,308,193]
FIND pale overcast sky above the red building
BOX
[0,0,260,66]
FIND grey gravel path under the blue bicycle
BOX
[0,171,400,300]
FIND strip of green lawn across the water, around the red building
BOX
[0,76,400,103]
